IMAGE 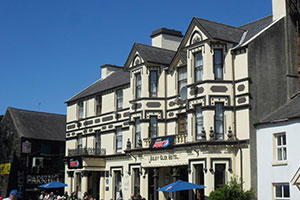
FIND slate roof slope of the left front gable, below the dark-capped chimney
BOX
[134,43,176,65]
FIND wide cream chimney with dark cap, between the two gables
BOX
[150,28,182,51]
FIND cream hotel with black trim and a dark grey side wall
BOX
[66,0,298,200]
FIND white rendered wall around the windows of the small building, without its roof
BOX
[257,120,300,200]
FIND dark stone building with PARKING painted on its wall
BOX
[0,107,66,199]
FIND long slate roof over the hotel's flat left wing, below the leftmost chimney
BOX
[66,70,130,103]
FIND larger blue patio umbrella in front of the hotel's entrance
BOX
[157,180,205,192]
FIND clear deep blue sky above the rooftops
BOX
[0,0,272,114]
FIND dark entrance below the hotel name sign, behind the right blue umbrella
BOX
[148,165,189,200]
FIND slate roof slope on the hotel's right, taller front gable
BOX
[194,17,245,43]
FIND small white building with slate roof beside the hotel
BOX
[257,95,300,200]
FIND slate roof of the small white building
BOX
[260,94,300,124]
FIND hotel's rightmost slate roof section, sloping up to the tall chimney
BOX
[239,15,273,43]
